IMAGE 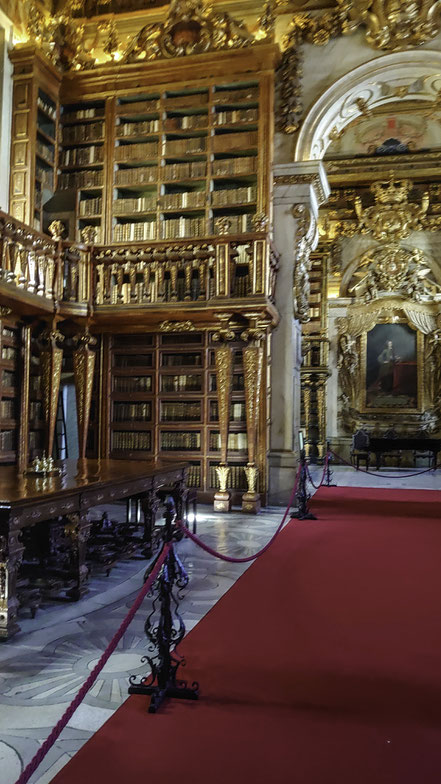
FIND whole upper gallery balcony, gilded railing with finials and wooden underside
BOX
[0,212,278,327]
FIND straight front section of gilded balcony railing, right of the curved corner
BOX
[91,234,278,307]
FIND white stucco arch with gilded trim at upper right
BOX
[294,49,441,161]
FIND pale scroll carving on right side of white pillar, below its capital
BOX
[292,204,317,324]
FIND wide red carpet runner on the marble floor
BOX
[54,488,441,784]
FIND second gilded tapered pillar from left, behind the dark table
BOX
[73,330,96,458]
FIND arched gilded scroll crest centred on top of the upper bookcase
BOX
[123,0,254,63]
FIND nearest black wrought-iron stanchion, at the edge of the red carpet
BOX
[129,498,199,713]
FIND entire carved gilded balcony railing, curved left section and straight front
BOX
[0,212,278,312]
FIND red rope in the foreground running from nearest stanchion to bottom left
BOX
[16,542,172,784]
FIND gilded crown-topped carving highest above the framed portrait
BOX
[355,172,429,242]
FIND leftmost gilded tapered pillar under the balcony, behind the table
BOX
[40,327,64,457]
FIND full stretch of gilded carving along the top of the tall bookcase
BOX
[18,0,277,71]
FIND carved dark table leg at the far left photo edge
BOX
[0,524,24,640]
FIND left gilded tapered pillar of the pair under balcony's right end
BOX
[213,313,235,512]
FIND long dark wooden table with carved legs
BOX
[0,460,187,639]
